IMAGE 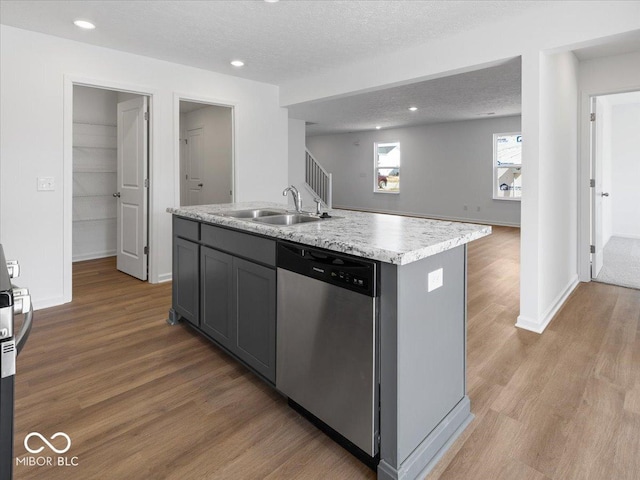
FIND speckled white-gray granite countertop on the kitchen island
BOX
[167,202,491,265]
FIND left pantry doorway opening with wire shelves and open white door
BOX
[72,84,150,281]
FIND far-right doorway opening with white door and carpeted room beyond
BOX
[591,91,640,289]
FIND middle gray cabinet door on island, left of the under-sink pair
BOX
[200,247,235,350]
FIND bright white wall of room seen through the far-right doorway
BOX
[609,103,640,239]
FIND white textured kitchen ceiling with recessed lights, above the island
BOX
[0,0,553,84]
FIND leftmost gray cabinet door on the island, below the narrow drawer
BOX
[172,237,200,326]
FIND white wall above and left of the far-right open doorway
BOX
[578,52,640,282]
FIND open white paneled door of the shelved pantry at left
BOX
[116,96,148,280]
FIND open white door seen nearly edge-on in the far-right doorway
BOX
[591,97,608,278]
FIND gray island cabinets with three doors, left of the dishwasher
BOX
[173,217,276,383]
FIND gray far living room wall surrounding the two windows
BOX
[307,116,520,225]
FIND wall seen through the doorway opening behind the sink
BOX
[180,105,233,205]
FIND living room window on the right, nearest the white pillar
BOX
[493,133,522,200]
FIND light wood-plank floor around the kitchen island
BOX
[14,227,640,480]
